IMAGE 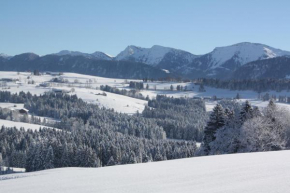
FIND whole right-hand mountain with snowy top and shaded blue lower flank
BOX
[177,42,290,79]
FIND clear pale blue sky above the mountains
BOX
[0,0,290,56]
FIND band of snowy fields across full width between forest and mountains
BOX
[0,72,290,114]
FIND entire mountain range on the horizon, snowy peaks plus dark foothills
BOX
[0,42,290,79]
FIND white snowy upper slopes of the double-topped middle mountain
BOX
[115,45,196,66]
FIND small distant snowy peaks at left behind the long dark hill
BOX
[55,50,112,60]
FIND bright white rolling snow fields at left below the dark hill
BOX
[0,71,147,114]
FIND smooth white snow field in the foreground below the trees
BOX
[0,151,290,193]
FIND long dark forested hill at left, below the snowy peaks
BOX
[0,53,171,79]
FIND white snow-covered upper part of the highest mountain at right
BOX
[209,42,290,68]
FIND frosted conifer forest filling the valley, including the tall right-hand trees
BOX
[0,91,290,172]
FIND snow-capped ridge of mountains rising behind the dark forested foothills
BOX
[0,42,290,79]
